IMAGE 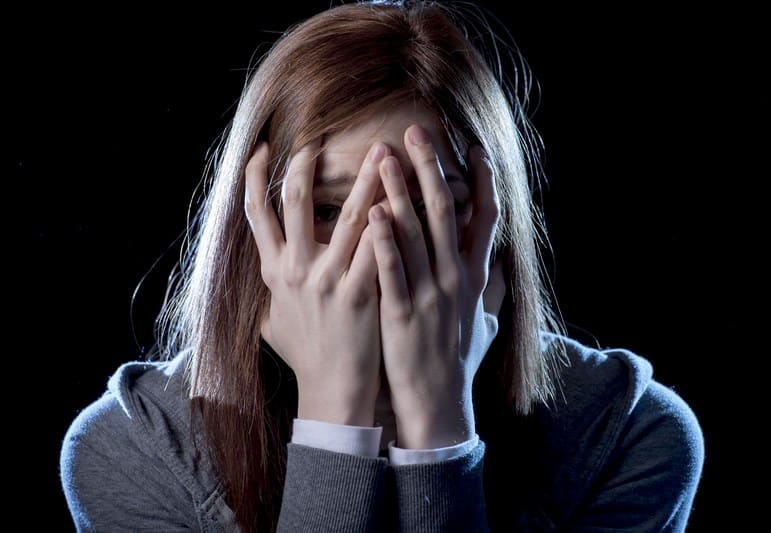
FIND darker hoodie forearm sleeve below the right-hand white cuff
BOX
[392,440,490,533]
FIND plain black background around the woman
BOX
[13,1,753,531]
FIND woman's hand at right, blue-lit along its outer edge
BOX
[369,125,505,449]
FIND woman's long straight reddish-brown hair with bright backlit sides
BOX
[158,1,560,531]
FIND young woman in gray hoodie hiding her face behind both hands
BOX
[61,1,703,532]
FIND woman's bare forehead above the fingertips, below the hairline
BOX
[316,102,461,185]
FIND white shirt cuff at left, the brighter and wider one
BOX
[292,418,383,457]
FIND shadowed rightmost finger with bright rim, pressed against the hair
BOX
[466,145,500,290]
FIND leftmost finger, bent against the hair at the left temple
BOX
[244,142,284,262]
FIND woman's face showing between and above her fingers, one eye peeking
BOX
[313,103,471,243]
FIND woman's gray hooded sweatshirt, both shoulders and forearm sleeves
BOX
[61,336,704,533]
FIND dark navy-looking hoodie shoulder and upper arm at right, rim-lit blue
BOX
[537,336,704,525]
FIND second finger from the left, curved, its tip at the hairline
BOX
[281,141,319,257]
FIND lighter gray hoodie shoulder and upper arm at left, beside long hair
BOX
[60,353,235,529]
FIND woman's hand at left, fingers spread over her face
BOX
[245,142,387,426]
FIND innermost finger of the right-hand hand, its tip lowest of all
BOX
[369,205,412,318]
